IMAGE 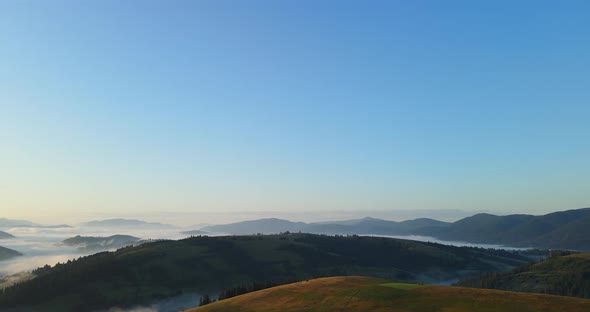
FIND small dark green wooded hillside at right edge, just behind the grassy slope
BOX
[458,253,590,298]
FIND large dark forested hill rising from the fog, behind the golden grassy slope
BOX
[0,234,527,311]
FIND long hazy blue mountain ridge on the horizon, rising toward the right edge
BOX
[201,208,590,251]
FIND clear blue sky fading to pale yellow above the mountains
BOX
[0,0,590,223]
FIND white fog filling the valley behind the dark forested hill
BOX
[0,212,536,277]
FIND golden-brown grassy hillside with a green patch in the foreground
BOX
[191,276,590,312]
